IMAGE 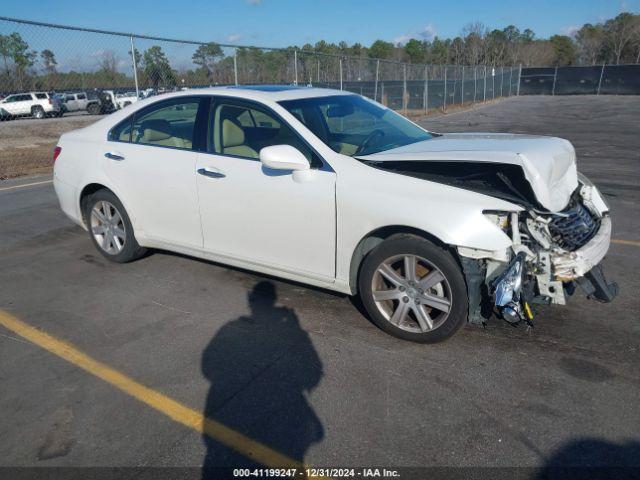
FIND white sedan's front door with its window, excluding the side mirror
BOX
[196,98,336,279]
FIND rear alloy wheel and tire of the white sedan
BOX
[83,189,146,263]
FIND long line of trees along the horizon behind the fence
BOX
[0,12,640,92]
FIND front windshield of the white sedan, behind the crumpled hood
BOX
[279,95,432,156]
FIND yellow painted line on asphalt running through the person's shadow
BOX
[0,310,304,469]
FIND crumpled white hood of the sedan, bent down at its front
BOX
[358,133,578,212]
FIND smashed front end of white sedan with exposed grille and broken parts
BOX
[458,175,618,324]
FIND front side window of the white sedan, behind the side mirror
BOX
[209,100,322,168]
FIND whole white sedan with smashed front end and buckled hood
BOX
[54,86,617,342]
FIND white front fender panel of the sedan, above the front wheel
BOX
[336,165,523,279]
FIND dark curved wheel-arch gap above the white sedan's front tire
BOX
[349,225,460,294]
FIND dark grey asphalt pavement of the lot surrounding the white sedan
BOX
[0,96,640,476]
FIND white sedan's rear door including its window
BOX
[104,96,208,249]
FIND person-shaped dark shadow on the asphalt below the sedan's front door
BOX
[202,281,324,478]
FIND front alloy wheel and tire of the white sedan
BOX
[358,235,468,343]
